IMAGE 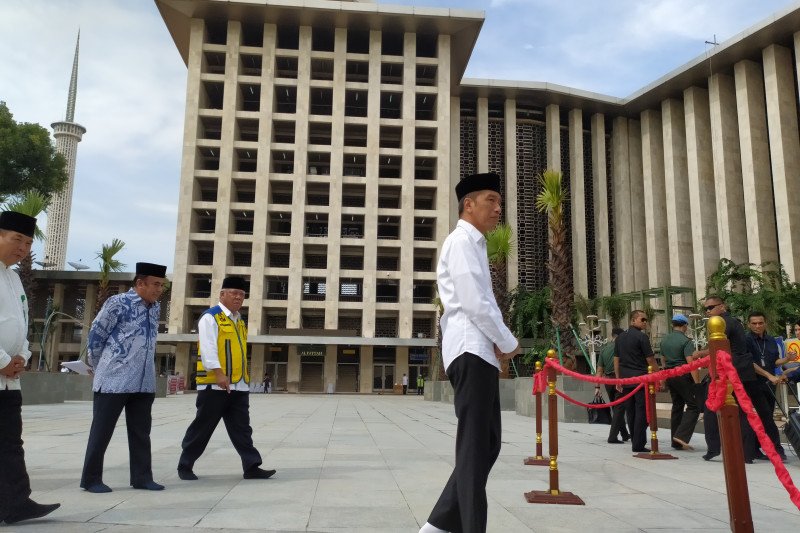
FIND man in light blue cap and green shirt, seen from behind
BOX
[661,314,700,450]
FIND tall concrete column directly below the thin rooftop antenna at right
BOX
[708,74,748,266]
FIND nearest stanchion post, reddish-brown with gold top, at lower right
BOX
[708,316,753,533]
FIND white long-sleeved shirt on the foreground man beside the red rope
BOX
[436,220,517,370]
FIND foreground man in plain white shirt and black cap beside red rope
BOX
[420,173,520,533]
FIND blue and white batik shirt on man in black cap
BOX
[87,289,161,393]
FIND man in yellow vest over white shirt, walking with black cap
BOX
[178,277,275,481]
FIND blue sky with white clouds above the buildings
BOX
[0,0,800,271]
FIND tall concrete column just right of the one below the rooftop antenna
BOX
[734,60,778,265]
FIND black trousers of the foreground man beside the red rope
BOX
[428,352,501,533]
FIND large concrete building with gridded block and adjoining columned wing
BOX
[156,0,800,392]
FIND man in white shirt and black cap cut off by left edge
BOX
[0,211,60,524]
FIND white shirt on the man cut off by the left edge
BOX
[0,261,31,390]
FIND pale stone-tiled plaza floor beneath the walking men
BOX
[6,394,800,533]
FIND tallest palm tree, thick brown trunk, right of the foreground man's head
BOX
[536,170,577,368]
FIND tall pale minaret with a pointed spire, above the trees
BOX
[44,30,86,270]
